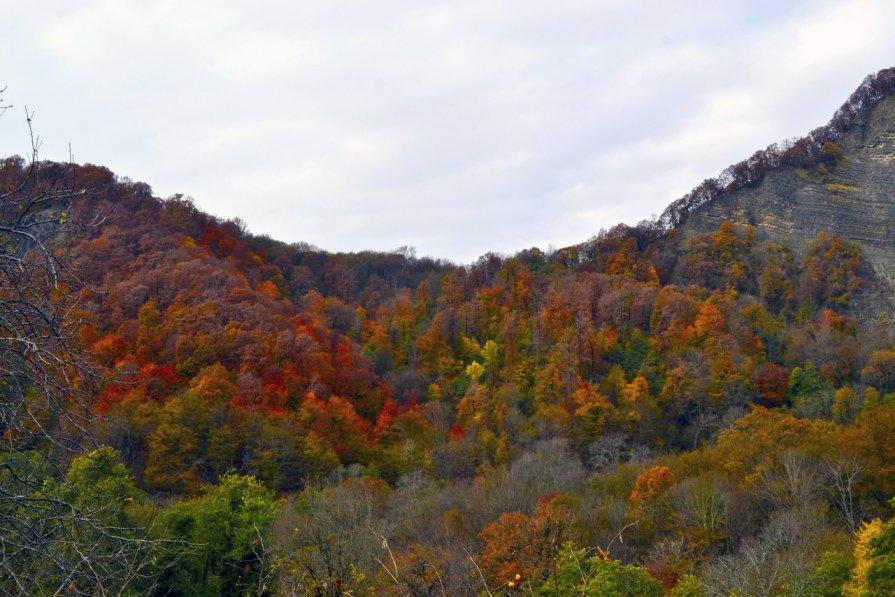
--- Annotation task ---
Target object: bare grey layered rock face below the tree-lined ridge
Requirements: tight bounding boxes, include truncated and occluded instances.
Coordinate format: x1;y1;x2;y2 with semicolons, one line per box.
678;95;895;310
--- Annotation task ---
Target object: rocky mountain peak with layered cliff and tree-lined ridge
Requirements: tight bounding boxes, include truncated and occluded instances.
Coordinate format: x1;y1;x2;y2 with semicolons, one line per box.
663;69;895;310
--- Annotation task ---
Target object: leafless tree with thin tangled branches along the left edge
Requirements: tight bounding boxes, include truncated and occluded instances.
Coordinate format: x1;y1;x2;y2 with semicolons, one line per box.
0;96;170;595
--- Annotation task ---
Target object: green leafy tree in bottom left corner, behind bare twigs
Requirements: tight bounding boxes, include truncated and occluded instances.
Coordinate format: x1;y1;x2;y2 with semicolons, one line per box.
0;448;166;595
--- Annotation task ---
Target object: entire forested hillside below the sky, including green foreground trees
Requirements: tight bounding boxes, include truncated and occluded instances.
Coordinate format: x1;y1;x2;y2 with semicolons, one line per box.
0;72;895;595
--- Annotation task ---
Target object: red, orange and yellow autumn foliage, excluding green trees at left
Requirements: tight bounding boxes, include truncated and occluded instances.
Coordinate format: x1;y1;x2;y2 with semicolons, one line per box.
4;155;895;594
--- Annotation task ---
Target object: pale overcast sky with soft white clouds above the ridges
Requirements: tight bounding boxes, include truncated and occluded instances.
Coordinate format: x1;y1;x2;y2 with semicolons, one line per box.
0;0;895;263
